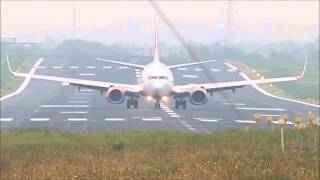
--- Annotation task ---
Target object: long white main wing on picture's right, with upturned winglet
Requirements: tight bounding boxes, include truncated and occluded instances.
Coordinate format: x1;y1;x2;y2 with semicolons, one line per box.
173;58;308;96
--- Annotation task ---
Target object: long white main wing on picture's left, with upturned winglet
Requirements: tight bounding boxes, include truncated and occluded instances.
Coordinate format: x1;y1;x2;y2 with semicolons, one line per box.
7;56;140;93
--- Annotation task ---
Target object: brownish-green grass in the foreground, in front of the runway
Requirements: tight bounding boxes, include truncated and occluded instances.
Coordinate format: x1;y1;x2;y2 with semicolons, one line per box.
1;128;319;180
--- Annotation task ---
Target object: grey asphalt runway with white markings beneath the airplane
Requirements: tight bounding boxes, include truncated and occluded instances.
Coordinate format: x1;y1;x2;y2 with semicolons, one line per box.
0;57;319;132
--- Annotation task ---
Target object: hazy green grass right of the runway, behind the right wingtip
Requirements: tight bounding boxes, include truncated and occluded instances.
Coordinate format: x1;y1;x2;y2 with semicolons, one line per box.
234;59;320;103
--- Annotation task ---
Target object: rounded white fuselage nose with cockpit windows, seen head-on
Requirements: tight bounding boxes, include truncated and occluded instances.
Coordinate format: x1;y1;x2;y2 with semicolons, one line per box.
141;61;173;98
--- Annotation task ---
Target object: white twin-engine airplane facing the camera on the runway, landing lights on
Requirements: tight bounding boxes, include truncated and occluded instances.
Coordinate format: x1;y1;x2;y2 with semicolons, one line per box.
6;11;308;109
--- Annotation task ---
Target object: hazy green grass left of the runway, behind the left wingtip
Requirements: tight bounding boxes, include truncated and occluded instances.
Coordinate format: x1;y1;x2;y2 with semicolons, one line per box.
0;56;37;96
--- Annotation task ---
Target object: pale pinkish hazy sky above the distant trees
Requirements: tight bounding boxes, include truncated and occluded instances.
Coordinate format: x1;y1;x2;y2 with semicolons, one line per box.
1;0;319;43
